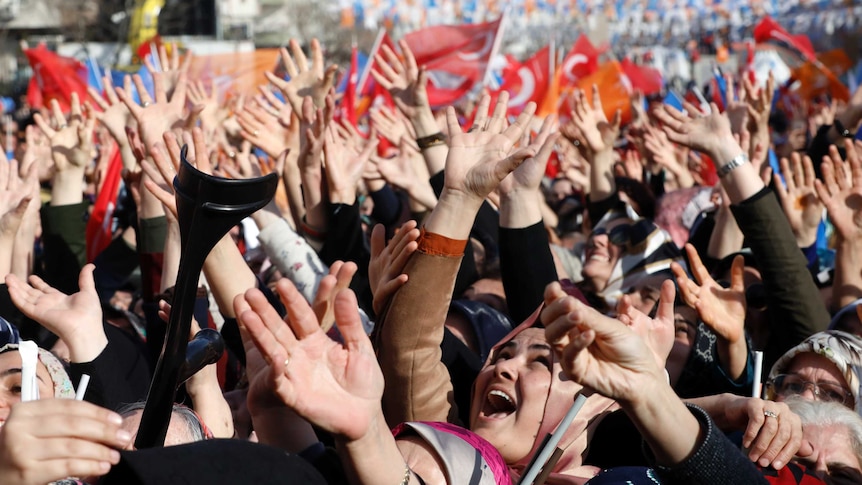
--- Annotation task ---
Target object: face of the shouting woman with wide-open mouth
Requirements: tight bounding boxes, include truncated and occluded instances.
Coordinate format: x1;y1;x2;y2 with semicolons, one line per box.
470;328;562;464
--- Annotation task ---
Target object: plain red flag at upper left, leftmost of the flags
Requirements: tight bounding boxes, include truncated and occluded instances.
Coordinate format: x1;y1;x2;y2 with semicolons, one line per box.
24;44;87;112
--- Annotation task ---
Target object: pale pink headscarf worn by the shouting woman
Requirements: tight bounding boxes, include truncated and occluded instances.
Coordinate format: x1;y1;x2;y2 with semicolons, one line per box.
485;306;619;485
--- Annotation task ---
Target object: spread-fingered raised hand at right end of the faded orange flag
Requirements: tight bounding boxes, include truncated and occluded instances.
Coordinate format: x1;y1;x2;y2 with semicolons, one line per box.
265;39;338;113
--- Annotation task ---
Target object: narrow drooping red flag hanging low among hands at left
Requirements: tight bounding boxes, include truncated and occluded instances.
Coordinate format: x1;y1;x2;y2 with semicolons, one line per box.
85;145;123;263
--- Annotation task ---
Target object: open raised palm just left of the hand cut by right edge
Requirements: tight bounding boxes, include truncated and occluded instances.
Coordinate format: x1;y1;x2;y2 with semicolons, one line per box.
772;152;823;248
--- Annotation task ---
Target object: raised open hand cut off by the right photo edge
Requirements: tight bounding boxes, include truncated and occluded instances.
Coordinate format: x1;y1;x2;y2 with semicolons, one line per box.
814;140;862;240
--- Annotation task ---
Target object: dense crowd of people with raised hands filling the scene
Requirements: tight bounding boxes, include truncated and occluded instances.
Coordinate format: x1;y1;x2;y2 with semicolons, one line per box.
0;27;862;485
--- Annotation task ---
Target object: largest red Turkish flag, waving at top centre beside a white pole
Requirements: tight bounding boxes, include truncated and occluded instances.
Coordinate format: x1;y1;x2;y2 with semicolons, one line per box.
404;17;502;106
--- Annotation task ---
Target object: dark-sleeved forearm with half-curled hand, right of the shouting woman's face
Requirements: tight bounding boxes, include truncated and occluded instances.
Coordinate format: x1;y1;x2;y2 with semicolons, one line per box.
541;283;766;483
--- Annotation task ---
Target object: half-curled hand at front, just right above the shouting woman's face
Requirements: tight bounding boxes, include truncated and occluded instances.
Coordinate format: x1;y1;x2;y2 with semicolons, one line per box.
540;283;665;402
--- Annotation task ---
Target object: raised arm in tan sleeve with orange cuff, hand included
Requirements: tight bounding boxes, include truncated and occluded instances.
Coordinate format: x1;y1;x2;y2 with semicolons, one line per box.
375;100;535;424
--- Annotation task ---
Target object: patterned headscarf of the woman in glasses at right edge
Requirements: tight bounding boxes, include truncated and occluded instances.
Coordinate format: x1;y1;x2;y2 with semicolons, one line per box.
768;330;862;415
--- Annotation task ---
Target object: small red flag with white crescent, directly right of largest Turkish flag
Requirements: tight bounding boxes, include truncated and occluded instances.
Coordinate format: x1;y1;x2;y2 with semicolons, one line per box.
500;46;551;115
